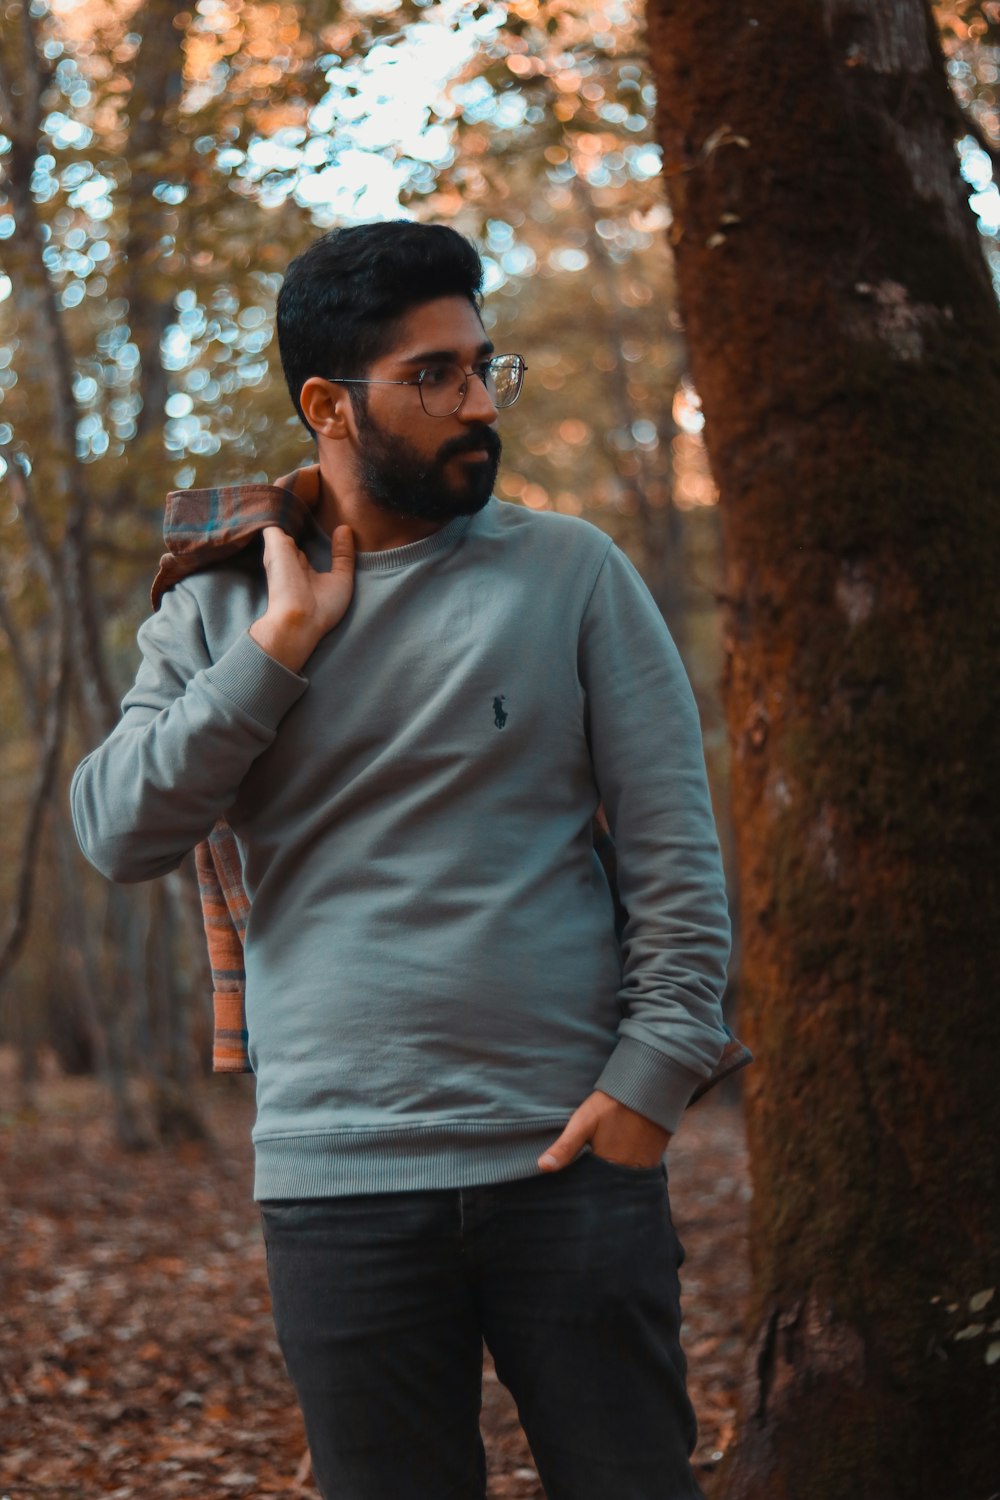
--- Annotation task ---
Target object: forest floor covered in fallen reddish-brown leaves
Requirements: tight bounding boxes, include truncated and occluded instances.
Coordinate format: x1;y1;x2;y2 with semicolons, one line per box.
0;1058;750;1500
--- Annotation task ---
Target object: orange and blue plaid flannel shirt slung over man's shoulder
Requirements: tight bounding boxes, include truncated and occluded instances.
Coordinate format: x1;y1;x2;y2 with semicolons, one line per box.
151;485;753;1104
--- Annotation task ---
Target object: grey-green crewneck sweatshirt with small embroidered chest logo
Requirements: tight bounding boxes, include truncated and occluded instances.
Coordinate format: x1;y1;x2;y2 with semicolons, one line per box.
70;500;729;1199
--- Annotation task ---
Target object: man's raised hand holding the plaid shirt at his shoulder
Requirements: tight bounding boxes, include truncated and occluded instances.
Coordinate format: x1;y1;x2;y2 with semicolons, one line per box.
250;525;354;672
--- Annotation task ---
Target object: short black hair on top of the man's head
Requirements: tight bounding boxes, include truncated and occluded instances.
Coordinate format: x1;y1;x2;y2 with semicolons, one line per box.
277;219;483;437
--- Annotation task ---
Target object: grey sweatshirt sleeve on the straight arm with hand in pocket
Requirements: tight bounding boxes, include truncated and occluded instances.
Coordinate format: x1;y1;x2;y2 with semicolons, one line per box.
579;546;730;1131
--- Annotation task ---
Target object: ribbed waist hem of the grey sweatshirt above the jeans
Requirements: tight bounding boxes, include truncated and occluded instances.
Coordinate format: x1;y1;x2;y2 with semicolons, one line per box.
253;1115;567;1202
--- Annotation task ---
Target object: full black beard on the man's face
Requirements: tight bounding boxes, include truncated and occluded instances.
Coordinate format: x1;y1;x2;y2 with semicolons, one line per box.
357;410;501;521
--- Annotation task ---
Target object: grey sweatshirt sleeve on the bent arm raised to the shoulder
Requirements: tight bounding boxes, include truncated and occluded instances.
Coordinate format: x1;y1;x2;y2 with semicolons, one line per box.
70;584;309;882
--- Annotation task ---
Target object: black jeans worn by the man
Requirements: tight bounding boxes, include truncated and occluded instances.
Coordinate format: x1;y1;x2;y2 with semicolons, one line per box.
261;1152;702;1500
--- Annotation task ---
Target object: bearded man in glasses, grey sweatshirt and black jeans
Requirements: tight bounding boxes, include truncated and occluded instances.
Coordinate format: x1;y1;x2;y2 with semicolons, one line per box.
72;222;729;1500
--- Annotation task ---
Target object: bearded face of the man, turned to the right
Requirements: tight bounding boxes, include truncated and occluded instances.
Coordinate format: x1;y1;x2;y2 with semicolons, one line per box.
355;297;501;521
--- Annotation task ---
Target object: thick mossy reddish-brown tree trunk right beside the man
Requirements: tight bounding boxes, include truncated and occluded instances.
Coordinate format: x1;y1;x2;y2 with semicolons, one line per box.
648;0;1000;1500
